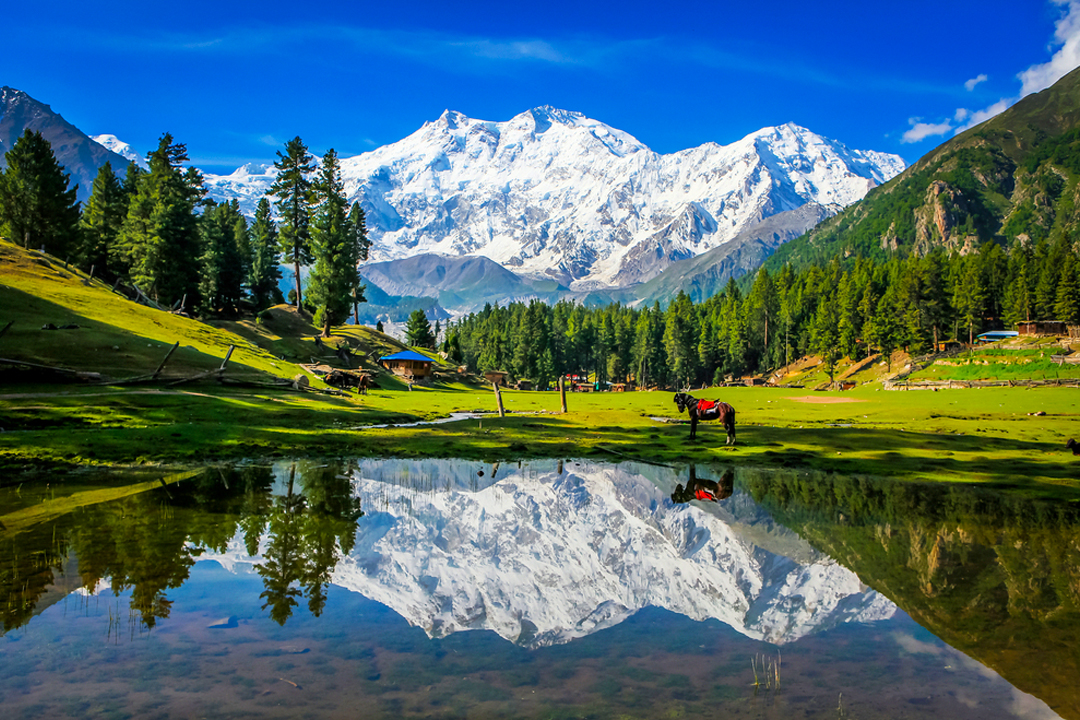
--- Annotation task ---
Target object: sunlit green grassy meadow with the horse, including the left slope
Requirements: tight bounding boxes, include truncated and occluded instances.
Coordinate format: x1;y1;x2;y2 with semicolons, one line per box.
0;237;1080;500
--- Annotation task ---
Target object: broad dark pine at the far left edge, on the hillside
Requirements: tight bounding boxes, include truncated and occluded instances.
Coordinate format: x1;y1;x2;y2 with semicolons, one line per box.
0;128;79;258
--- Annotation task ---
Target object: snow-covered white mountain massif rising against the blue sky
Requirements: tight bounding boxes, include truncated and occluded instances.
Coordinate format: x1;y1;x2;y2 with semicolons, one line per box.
200;107;904;289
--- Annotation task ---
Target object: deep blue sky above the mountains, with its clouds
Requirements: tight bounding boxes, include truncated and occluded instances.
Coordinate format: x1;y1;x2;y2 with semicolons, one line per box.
6;0;1080;172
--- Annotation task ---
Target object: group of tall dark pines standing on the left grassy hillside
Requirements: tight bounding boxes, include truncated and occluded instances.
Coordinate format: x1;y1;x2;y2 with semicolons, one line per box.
0;130;370;335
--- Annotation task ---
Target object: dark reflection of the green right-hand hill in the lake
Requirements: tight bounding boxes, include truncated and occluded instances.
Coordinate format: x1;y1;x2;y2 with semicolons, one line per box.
743;471;1080;718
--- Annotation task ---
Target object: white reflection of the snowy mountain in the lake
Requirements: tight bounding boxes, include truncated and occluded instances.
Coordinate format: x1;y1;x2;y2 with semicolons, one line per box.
203;461;895;647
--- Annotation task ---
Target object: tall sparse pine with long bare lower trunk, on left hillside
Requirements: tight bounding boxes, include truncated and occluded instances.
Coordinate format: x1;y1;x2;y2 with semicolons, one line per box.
267;136;315;310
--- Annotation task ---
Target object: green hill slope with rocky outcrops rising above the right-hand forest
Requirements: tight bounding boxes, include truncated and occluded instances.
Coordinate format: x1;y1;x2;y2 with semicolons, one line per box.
765;64;1080;272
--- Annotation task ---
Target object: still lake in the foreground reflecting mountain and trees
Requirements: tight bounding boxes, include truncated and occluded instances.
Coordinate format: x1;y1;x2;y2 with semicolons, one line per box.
0;460;1080;719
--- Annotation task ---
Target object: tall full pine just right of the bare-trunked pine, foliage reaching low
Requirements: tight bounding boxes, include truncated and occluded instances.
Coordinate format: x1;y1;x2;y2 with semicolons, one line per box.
308;149;357;337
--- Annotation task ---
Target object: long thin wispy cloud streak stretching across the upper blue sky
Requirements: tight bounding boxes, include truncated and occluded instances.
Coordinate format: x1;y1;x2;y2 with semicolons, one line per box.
39;24;949;94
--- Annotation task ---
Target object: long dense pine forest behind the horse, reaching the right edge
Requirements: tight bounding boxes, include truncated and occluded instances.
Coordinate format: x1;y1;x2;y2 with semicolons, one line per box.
441;235;1080;386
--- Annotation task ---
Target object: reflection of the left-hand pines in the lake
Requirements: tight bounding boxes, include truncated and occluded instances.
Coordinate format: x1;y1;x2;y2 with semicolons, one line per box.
0;463;363;633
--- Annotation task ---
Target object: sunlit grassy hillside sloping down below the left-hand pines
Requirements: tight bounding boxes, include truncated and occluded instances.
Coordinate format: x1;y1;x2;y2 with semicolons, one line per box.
0;240;438;382
